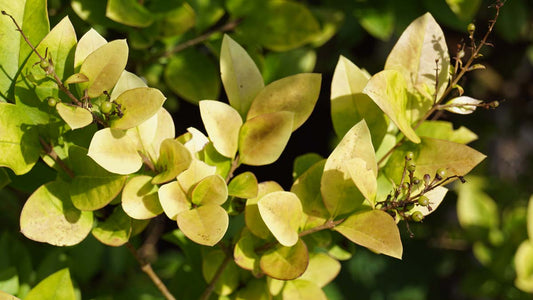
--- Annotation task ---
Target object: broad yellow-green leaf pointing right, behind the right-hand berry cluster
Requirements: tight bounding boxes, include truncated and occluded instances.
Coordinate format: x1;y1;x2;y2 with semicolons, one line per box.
384;138;486;182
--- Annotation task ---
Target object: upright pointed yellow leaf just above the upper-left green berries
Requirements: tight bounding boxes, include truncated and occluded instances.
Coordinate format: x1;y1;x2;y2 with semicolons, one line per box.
80;40;128;98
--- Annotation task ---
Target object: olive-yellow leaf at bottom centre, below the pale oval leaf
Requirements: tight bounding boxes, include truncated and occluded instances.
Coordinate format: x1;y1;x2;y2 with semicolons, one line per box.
259;239;309;280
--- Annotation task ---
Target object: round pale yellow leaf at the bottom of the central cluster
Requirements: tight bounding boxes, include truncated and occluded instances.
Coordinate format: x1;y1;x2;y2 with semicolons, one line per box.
177;204;229;246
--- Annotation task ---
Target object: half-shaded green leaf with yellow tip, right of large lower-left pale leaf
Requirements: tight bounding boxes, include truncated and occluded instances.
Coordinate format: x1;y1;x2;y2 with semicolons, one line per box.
92;206;132;247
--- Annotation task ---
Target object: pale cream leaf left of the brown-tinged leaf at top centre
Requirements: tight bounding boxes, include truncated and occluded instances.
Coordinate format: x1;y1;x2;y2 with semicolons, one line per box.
199;100;242;158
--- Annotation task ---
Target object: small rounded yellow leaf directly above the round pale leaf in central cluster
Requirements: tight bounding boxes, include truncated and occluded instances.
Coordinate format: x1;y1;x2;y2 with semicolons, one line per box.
191;175;228;205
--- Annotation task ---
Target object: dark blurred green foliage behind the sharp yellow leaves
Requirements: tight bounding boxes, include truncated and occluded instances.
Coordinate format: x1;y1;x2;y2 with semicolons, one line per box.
0;0;533;300
